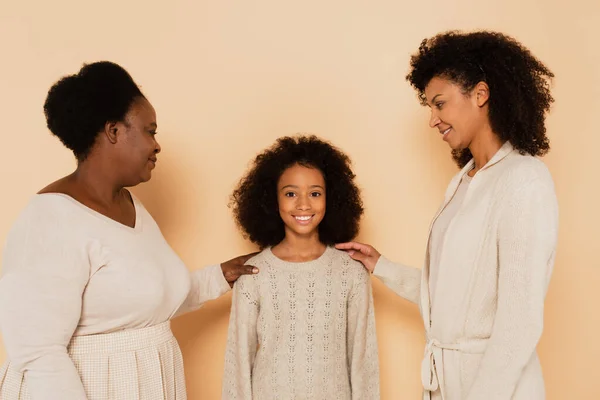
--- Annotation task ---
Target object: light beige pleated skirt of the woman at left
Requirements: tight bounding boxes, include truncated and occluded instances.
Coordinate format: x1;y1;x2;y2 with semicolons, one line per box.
0;322;186;400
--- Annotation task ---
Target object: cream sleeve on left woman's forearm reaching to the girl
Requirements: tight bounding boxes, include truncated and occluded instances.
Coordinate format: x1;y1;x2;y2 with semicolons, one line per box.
175;264;231;316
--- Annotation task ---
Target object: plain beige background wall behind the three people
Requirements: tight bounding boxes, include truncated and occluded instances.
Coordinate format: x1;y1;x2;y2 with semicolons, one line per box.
0;0;600;400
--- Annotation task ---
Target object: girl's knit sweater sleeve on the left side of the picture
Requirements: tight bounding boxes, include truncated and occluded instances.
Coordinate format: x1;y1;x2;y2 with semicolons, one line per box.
222;275;260;400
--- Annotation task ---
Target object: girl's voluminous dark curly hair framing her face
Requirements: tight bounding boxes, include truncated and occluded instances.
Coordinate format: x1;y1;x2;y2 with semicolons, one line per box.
229;136;363;248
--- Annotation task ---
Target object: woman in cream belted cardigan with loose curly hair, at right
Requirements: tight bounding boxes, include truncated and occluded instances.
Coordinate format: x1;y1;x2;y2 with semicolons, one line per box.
339;32;558;400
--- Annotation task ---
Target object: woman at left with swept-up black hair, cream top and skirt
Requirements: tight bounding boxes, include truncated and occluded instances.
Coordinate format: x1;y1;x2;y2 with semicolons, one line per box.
0;62;257;400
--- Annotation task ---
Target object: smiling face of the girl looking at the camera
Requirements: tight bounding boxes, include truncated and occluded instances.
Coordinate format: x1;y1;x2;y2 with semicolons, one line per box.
277;164;326;238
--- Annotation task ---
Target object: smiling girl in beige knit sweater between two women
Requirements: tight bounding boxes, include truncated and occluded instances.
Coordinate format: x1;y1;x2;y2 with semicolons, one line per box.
222;136;379;400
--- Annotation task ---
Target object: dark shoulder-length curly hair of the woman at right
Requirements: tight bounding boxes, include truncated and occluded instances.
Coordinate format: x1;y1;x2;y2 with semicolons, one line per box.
406;31;554;167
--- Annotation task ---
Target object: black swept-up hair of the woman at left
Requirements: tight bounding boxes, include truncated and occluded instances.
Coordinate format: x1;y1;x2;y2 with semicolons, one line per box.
44;61;144;161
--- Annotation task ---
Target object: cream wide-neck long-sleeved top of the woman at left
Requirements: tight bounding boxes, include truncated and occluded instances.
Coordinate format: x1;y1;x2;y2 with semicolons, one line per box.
0;193;230;400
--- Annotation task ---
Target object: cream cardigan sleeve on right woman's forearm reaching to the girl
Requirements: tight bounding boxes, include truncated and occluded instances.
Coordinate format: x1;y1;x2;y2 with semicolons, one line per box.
373;256;421;304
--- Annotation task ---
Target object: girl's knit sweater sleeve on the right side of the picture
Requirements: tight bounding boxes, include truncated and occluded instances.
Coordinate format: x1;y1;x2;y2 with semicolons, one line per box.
347;266;379;400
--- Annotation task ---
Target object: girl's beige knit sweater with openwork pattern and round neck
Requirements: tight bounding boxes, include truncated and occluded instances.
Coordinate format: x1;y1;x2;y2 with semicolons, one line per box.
222;247;379;400
